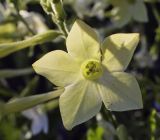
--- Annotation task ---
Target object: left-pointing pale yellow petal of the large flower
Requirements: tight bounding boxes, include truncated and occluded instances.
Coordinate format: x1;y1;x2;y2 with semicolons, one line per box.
33;50;80;86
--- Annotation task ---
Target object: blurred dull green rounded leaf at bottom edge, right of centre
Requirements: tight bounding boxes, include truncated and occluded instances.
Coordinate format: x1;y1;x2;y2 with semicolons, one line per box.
116;124;129;140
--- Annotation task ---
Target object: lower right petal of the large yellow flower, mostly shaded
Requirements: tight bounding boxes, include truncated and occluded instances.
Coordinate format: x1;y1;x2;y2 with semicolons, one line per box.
98;72;143;111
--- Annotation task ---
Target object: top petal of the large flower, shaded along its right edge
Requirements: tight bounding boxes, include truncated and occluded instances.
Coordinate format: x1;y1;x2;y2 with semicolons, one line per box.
66;20;100;60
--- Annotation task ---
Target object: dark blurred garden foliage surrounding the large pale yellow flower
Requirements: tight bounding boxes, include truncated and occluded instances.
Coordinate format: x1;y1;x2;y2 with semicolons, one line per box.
0;0;160;140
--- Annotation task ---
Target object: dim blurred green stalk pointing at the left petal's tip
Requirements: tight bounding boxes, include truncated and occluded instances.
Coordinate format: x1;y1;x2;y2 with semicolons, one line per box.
0;68;33;78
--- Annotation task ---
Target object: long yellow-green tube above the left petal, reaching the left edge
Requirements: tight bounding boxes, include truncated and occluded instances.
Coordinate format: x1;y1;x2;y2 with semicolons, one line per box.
0;30;60;58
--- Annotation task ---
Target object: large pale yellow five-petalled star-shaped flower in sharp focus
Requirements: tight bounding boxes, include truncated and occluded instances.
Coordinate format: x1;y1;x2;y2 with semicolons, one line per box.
33;20;143;130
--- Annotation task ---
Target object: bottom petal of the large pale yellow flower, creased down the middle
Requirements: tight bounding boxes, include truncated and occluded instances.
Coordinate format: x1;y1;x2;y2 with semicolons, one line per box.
60;80;102;130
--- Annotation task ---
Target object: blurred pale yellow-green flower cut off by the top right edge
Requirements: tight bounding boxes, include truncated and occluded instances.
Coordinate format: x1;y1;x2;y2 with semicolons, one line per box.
109;0;148;27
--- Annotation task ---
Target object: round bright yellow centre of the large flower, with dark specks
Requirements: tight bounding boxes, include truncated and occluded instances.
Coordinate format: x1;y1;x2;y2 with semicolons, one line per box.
81;60;103;80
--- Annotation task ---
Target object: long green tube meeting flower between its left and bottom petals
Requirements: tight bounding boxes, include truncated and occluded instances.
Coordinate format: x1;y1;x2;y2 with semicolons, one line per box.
2;89;64;115
